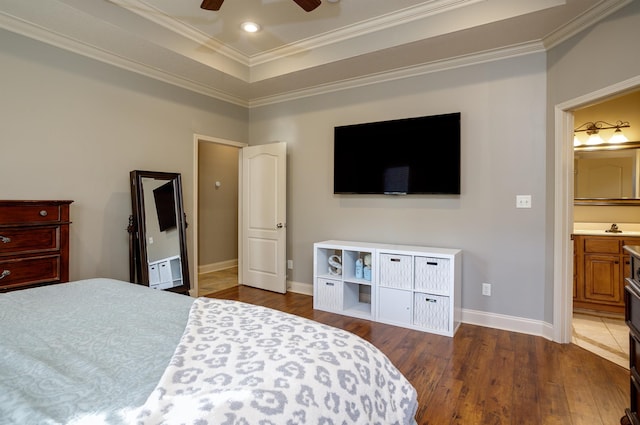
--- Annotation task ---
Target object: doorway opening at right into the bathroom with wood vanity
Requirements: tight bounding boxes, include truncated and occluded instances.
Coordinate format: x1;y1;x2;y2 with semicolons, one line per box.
572;90;640;368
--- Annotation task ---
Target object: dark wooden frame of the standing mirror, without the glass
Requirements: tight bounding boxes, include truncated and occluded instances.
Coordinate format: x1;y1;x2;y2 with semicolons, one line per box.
129;170;191;295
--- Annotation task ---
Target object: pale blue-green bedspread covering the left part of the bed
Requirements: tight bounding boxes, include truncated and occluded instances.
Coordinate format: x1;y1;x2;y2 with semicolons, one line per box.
0;279;193;424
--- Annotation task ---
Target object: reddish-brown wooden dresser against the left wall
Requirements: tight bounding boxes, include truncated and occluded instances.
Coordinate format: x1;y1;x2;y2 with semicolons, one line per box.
0;201;73;292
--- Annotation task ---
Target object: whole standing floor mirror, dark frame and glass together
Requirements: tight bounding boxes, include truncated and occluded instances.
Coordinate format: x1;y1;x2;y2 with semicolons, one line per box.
131;170;190;293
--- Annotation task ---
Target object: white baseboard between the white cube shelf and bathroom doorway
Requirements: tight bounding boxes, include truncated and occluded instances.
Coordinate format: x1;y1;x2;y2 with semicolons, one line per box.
462;309;553;340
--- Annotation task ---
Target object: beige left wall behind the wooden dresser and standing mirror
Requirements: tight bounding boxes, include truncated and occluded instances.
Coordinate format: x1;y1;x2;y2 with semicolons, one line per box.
0;30;248;280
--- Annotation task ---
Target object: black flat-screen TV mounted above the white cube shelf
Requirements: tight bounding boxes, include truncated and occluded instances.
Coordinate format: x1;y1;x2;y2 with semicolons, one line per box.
333;112;460;195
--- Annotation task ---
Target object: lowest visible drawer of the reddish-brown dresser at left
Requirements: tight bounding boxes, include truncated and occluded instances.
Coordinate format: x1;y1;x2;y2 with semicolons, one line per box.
0;255;61;291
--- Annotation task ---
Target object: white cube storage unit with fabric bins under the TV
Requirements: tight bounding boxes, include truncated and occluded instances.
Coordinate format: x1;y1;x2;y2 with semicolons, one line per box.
313;240;462;336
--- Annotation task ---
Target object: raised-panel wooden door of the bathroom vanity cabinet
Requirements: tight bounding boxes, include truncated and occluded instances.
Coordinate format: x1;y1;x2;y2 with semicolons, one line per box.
584;254;622;304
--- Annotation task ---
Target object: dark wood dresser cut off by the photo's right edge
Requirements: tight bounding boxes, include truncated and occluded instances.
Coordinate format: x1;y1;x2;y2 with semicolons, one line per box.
620;245;640;425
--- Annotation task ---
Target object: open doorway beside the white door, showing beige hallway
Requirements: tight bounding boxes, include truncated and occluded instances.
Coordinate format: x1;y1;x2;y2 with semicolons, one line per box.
193;135;247;296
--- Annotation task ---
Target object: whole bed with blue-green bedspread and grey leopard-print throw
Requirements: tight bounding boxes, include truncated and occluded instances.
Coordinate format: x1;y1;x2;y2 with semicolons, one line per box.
0;279;417;425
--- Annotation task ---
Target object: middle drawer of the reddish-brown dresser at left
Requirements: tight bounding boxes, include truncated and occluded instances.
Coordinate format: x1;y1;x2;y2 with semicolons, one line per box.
0;226;60;257
